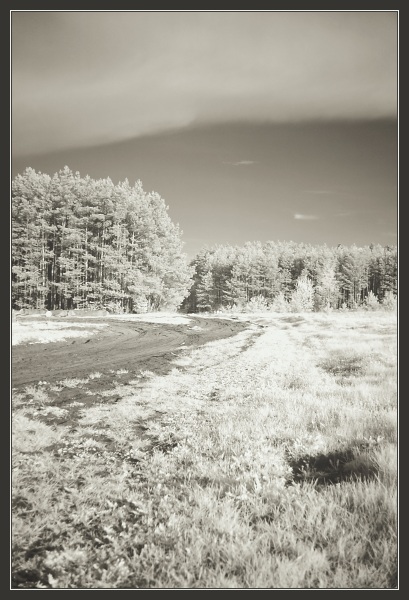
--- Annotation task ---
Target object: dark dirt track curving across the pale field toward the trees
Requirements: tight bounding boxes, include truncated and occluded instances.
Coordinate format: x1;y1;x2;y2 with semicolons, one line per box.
12;316;246;389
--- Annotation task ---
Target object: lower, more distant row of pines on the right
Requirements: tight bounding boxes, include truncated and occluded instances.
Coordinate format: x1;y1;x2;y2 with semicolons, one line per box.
183;241;398;312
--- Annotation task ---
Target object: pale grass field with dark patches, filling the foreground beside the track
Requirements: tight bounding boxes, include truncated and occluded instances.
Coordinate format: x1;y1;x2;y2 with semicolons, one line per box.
12;311;398;589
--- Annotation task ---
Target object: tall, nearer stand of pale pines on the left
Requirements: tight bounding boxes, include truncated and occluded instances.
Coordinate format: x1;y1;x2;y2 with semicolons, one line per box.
11;167;193;312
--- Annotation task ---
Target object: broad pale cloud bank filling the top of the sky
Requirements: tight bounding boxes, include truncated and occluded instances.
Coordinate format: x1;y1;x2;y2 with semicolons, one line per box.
12;11;397;157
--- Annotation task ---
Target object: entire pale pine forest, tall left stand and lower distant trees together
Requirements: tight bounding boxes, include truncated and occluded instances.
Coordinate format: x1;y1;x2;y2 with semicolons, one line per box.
11;167;398;312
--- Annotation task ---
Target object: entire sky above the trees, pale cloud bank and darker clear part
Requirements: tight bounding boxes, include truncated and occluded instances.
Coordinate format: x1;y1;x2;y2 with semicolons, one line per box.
11;11;398;257
